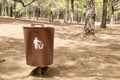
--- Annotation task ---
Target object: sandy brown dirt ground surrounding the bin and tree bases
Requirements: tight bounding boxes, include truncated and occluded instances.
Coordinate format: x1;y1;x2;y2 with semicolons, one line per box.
0;18;120;80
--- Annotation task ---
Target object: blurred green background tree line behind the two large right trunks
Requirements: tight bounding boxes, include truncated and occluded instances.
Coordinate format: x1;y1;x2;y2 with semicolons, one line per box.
0;0;120;23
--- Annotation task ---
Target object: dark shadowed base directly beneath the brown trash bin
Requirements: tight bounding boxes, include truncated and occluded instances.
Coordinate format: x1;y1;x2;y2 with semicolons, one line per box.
30;66;48;77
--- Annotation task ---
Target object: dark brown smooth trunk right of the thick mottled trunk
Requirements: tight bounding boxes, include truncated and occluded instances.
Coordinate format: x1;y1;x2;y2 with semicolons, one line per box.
100;0;108;28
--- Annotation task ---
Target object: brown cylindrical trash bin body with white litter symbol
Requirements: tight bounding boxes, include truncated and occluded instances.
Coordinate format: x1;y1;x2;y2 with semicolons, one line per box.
24;27;54;67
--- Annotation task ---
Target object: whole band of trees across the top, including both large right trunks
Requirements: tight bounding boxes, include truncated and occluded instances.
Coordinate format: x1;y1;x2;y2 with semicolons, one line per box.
0;0;120;33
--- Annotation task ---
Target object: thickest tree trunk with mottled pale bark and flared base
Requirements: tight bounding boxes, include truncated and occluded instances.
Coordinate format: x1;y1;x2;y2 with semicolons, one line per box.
84;0;95;35
